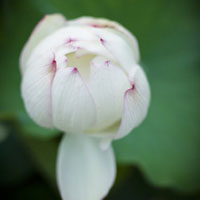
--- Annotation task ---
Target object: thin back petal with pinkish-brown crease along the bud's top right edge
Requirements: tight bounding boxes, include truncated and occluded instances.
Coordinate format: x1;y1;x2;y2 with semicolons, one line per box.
69;17;139;62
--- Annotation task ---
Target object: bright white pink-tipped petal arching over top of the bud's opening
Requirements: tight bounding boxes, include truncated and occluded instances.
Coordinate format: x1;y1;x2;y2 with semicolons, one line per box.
26;26;112;74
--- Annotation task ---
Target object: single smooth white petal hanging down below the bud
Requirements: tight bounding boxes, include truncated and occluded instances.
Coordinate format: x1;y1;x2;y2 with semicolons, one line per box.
57;135;116;200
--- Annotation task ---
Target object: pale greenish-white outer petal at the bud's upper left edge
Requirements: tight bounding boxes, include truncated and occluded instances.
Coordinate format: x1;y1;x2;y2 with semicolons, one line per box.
20;14;66;72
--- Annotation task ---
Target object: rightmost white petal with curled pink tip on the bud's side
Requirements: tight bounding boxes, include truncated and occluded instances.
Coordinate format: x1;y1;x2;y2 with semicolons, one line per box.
116;66;150;139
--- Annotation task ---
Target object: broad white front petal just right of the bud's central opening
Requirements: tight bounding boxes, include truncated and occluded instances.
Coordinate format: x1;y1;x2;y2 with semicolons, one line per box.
88;57;130;129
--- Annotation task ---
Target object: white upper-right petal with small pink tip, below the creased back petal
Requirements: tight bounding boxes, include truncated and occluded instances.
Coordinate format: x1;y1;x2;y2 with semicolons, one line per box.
92;28;139;72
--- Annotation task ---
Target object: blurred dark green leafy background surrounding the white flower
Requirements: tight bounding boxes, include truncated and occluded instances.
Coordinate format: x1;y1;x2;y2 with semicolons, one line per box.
0;0;200;200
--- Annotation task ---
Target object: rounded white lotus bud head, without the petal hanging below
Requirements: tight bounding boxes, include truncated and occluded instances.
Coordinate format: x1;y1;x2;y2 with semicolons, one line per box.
21;14;150;138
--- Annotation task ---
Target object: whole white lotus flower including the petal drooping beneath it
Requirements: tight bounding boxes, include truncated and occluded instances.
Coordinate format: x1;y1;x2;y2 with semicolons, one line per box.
20;14;150;200
